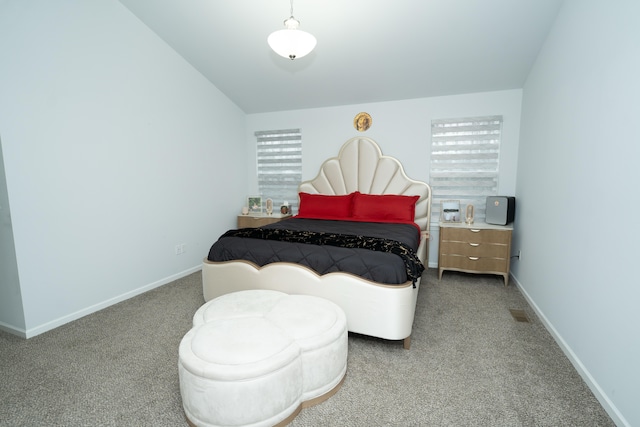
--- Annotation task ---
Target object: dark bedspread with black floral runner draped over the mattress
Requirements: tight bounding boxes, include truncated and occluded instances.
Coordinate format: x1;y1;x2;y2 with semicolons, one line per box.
208;218;424;285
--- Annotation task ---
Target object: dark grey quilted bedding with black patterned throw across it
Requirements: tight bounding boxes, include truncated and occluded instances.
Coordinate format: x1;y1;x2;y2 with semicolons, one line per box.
208;218;424;285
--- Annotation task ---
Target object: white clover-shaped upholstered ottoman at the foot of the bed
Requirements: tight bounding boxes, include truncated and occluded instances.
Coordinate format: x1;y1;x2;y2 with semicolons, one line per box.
178;290;347;427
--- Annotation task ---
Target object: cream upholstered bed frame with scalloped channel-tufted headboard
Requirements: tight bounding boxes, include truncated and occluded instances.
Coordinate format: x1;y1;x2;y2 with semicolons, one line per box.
202;137;431;349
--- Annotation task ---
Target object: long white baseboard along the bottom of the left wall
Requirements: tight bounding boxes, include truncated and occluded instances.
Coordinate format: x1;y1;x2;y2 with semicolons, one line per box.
21;264;202;339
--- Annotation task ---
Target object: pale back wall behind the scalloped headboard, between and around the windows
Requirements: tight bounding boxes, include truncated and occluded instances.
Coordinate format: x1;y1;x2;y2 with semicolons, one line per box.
246;90;522;267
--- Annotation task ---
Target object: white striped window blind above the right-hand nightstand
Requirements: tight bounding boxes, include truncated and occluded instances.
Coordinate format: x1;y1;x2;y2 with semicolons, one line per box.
429;116;502;224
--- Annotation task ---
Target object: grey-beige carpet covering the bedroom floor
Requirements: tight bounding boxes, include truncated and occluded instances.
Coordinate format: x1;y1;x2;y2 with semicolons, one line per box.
0;269;613;427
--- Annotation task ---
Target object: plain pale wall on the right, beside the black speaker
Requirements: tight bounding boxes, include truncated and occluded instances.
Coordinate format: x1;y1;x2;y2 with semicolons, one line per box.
513;0;640;425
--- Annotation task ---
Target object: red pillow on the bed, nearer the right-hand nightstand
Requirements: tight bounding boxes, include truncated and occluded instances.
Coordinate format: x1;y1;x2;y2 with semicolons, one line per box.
352;193;420;222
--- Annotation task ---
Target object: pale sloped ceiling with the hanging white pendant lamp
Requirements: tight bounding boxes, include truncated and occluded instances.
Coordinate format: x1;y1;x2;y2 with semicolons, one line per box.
120;0;563;114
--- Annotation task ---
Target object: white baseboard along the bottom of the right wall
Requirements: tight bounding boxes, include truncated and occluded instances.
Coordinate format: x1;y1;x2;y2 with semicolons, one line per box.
511;274;631;427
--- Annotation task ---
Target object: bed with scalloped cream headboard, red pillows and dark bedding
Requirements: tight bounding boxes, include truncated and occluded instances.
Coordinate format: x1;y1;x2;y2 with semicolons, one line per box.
202;137;431;349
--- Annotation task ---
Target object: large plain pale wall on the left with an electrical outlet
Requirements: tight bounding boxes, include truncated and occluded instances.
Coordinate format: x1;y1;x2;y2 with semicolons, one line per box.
0;0;247;336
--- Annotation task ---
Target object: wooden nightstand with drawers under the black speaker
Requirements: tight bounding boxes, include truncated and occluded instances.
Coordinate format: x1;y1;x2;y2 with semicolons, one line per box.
438;222;513;286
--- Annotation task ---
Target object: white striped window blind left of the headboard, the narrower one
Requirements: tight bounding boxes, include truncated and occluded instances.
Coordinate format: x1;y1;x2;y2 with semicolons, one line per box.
255;129;302;212
